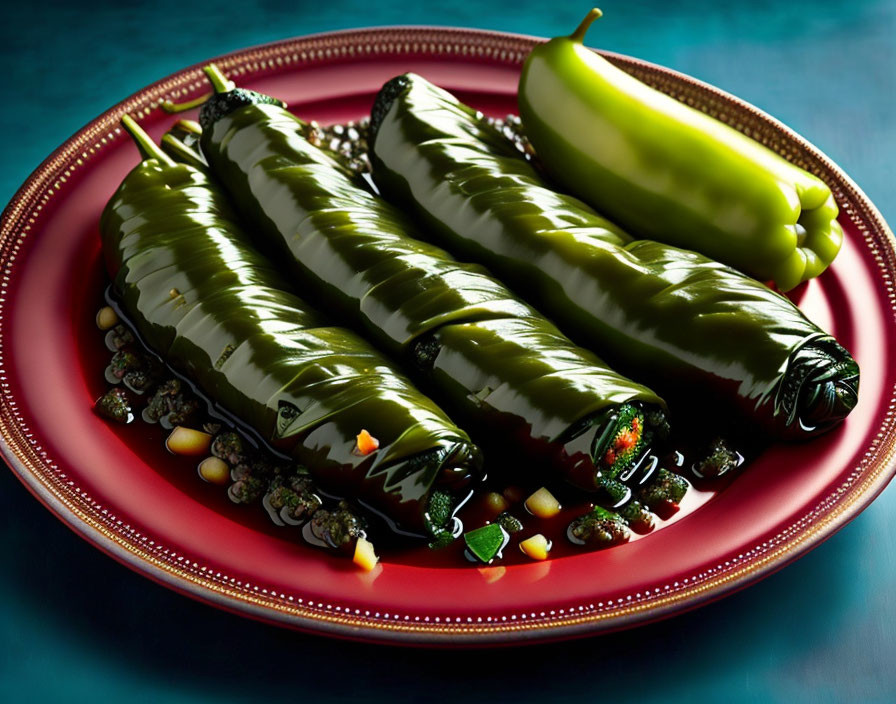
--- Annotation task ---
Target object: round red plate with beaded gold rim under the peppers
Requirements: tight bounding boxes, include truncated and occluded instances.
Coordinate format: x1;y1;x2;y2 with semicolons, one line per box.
0;28;896;644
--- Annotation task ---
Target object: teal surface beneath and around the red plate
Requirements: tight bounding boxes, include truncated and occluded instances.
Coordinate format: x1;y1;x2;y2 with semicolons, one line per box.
0;0;896;702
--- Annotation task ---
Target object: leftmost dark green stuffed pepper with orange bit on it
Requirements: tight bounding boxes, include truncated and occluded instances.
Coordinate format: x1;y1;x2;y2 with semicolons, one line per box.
100;118;481;535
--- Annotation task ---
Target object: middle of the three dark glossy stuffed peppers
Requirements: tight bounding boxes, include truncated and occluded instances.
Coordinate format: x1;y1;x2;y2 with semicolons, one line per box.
201;93;664;491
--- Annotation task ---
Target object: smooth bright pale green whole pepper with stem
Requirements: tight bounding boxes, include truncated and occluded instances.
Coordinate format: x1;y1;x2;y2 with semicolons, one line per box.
518;11;843;291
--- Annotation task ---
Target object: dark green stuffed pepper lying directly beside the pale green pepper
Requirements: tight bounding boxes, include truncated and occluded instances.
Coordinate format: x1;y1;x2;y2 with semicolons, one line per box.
371;74;858;438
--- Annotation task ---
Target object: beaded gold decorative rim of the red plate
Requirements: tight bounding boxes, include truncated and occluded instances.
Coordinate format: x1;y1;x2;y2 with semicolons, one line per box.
0;27;896;645
